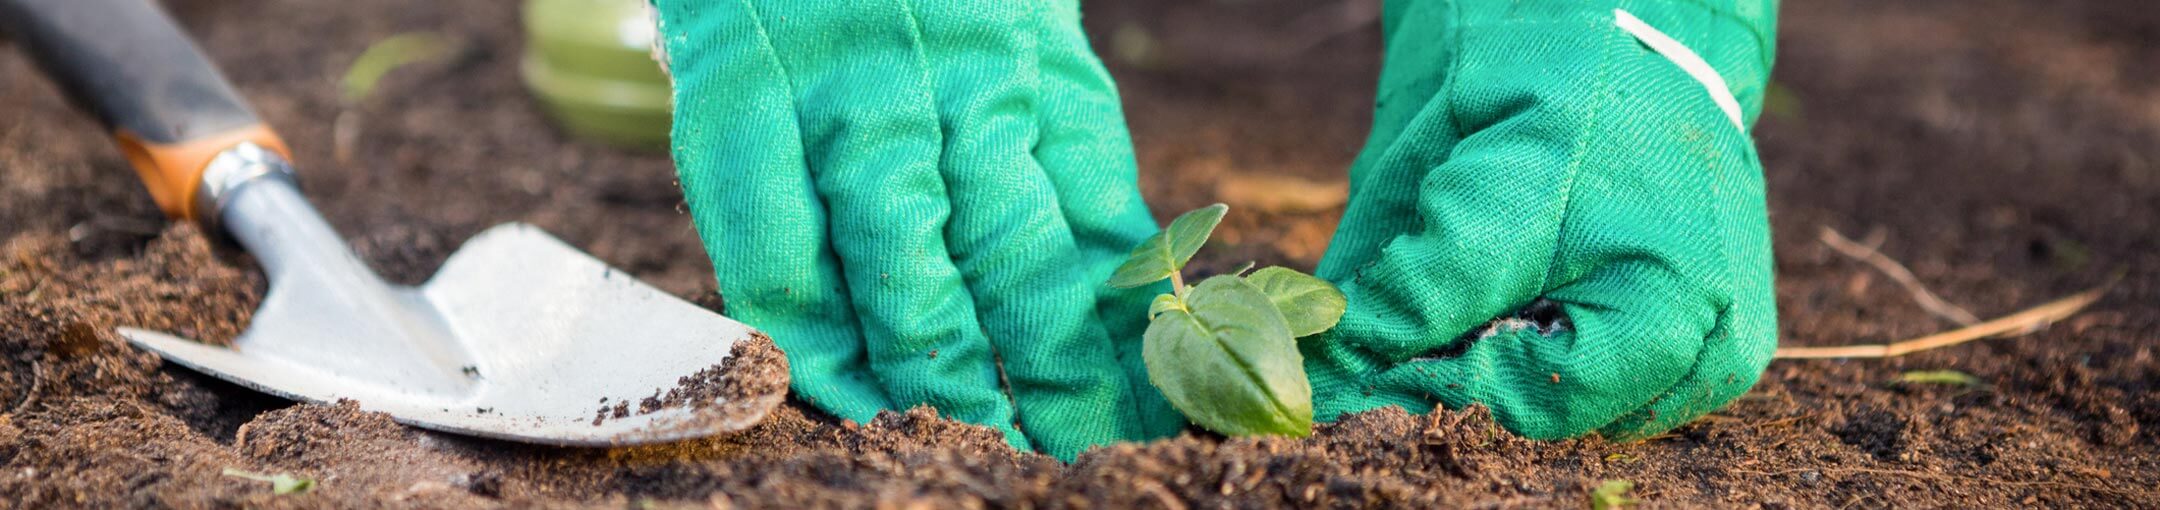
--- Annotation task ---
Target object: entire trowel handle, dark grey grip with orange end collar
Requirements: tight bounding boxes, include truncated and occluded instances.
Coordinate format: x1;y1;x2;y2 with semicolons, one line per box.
0;0;292;220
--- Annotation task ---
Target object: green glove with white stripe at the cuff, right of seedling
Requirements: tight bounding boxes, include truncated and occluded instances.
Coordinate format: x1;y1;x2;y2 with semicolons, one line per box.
1302;0;1778;441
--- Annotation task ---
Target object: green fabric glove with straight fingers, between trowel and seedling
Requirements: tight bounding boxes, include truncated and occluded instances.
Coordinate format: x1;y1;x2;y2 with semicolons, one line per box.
657;0;1184;458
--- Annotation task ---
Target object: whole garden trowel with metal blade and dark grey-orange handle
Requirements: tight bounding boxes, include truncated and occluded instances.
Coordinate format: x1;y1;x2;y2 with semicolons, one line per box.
0;0;786;445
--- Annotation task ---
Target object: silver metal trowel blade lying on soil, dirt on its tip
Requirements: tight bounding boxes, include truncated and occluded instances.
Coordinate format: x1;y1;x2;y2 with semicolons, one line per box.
121;223;782;445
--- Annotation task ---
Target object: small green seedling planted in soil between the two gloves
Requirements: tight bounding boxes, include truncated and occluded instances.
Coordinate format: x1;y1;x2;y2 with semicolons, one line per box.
1110;203;1348;437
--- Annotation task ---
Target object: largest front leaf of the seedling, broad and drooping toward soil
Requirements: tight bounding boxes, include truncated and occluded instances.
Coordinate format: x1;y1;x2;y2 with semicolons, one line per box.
1140;274;1313;437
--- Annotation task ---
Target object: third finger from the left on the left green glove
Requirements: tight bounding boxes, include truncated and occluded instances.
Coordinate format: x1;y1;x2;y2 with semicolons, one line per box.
920;0;1138;460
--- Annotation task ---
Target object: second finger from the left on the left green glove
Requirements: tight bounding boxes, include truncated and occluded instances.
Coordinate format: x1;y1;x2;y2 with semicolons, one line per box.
756;0;1026;447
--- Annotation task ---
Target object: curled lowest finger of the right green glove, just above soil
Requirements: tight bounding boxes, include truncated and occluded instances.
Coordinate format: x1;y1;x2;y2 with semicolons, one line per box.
1372;259;1728;439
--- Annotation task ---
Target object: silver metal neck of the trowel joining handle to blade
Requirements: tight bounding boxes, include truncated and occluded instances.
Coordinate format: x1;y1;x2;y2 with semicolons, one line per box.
194;143;469;385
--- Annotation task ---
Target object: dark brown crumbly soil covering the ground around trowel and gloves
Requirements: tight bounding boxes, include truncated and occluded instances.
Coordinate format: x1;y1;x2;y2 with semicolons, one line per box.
0;0;2160;508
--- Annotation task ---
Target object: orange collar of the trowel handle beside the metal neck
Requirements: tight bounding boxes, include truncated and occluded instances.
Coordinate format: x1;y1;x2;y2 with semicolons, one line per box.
112;123;292;220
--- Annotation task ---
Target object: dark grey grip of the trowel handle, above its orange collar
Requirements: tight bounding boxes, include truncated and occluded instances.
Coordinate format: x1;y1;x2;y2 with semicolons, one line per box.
0;0;259;145
